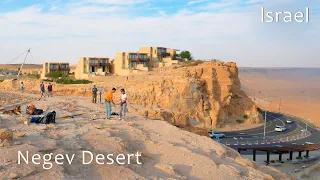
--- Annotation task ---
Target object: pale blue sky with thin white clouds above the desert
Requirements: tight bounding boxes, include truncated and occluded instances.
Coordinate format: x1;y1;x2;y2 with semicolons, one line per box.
0;0;320;67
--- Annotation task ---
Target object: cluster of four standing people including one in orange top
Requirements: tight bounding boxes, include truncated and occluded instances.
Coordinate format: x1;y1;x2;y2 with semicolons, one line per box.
92;85;127;121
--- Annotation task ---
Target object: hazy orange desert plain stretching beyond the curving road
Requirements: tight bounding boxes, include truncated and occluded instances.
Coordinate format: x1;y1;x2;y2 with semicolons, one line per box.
239;68;320;126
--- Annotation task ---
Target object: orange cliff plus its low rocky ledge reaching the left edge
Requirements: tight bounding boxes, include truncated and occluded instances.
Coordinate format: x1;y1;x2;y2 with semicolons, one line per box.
0;62;262;127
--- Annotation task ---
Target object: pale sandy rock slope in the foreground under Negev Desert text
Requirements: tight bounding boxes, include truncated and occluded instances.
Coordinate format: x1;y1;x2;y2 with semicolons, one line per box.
0;92;288;180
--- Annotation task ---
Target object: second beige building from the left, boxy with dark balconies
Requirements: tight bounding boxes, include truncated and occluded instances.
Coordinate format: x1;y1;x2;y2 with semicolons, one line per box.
74;57;112;79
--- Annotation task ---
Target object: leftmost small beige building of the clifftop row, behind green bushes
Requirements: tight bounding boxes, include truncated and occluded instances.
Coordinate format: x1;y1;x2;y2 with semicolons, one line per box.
41;62;70;78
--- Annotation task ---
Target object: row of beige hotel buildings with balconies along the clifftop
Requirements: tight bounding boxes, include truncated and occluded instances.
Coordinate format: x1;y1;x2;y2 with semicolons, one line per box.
42;47;179;79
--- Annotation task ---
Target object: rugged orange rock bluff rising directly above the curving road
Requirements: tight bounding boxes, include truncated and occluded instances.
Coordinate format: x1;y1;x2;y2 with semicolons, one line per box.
129;62;262;127
